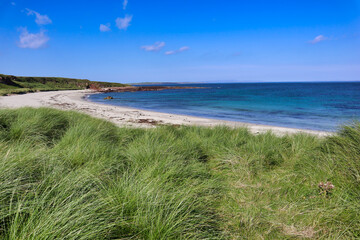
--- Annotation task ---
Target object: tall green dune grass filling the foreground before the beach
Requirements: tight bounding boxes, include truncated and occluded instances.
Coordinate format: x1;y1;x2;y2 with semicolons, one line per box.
0;108;360;240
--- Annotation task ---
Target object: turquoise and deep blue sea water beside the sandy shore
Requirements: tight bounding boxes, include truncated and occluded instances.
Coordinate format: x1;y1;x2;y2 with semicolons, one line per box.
88;82;360;131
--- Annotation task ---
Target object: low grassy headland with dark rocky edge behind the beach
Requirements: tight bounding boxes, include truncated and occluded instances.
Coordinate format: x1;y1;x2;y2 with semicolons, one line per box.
0;74;127;96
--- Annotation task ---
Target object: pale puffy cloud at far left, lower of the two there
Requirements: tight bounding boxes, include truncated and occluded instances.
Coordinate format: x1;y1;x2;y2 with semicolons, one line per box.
18;28;50;49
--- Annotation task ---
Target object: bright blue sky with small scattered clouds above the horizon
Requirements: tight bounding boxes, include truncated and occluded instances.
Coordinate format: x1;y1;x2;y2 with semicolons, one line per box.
0;0;360;83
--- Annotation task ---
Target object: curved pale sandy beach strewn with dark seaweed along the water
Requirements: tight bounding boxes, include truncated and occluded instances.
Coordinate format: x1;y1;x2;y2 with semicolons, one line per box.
0;90;332;136
